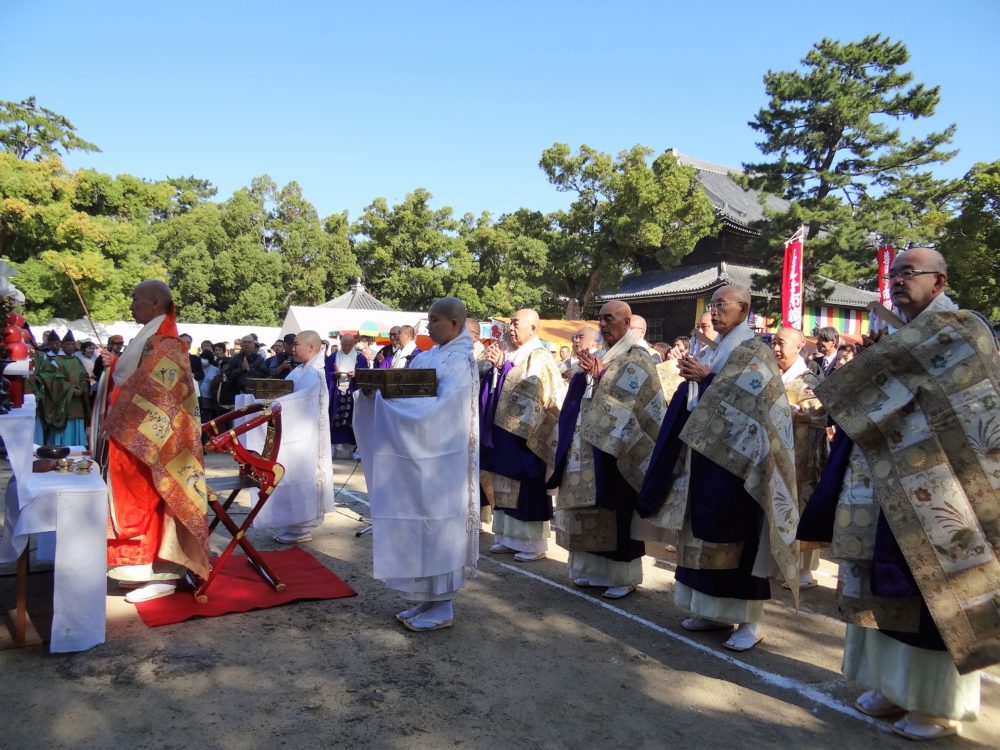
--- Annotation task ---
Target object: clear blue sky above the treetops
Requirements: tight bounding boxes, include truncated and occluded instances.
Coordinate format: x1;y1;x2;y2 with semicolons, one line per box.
0;0;1000;218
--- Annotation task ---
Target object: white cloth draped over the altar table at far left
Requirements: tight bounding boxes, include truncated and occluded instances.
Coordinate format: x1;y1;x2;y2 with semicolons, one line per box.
0;398;108;652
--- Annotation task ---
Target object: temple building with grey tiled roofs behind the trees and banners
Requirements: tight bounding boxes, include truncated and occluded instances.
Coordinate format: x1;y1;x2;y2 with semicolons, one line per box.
598;150;878;342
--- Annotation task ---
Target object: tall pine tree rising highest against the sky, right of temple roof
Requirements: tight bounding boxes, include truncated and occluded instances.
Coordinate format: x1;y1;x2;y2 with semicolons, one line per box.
744;35;955;290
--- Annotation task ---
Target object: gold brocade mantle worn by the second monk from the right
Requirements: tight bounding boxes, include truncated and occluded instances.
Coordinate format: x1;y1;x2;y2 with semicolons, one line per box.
660;339;799;598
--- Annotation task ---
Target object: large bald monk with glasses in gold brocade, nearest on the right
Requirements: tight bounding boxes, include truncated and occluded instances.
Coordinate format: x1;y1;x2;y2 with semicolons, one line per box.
799;247;1000;740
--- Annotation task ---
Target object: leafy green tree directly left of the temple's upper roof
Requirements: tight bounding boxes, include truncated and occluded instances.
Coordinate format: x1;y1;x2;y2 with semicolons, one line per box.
539;143;716;309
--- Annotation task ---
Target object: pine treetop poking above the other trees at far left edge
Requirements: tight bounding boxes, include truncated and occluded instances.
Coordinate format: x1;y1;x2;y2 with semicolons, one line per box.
0;96;100;159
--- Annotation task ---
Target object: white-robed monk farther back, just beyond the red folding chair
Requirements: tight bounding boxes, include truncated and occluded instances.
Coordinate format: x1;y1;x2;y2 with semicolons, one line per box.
253;331;334;544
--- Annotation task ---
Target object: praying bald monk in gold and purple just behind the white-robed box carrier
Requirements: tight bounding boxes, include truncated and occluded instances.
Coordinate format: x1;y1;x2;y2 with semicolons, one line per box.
480;309;565;562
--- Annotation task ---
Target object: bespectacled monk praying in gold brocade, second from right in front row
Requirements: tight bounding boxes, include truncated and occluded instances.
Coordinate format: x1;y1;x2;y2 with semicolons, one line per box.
637;285;799;651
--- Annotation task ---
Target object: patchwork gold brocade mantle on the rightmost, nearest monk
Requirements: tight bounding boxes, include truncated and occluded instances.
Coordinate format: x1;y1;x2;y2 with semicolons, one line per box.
817;311;1000;674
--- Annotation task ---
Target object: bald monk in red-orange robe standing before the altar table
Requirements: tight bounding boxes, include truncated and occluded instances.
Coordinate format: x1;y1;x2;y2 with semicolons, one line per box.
102;280;209;602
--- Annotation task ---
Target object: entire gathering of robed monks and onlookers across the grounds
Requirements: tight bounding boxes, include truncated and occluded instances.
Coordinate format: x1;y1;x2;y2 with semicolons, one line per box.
25;248;1000;740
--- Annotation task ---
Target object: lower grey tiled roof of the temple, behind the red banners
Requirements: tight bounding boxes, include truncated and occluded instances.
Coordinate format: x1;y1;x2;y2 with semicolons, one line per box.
601;262;878;307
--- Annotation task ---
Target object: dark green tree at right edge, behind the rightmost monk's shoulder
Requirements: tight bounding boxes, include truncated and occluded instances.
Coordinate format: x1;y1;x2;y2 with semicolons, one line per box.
941;160;1000;323
